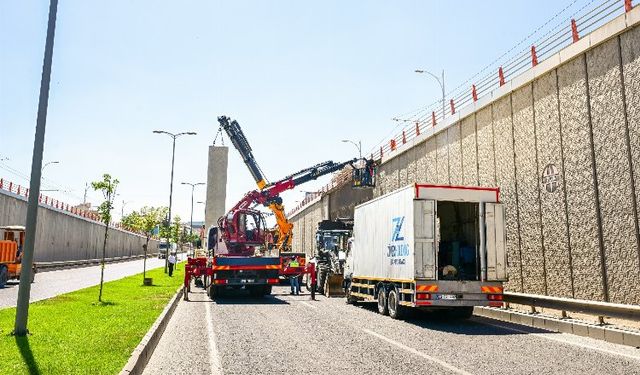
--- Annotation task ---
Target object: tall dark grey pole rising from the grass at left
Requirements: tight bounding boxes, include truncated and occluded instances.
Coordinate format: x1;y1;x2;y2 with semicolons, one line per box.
13;0;58;336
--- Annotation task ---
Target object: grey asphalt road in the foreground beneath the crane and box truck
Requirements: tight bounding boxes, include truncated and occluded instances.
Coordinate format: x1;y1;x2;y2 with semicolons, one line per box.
145;287;640;375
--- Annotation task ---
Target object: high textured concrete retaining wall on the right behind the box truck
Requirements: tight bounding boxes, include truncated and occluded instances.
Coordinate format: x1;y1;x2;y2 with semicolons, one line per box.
293;8;640;304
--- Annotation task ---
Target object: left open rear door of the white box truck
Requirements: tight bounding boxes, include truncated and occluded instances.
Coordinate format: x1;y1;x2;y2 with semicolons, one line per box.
413;200;437;280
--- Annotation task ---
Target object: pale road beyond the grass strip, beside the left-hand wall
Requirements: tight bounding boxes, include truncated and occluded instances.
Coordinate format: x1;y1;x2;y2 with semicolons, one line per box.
0;258;164;309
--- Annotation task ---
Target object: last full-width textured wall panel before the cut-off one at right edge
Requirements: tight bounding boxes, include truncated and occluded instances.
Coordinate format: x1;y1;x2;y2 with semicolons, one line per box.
587;38;640;303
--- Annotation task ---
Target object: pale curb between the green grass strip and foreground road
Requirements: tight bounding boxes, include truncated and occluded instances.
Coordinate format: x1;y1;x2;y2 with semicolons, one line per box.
120;286;184;375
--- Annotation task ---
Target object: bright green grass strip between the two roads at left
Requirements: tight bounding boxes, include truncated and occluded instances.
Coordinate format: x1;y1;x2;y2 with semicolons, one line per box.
0;264;184;374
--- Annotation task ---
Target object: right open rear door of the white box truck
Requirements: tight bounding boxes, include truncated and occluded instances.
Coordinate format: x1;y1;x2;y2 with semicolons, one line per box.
484;203;507;281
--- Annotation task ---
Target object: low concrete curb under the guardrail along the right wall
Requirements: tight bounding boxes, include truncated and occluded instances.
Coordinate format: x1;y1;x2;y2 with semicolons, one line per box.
473;307;640;348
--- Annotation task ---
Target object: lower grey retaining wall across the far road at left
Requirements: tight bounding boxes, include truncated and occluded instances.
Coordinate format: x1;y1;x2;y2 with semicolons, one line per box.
0;190;158;262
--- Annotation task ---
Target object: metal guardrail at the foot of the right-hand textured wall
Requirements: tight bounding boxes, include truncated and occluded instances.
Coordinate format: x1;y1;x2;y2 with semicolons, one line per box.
504;292;640;321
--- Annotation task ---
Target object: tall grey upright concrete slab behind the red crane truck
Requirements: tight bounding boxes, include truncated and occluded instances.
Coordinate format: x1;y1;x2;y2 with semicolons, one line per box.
204;146;229;230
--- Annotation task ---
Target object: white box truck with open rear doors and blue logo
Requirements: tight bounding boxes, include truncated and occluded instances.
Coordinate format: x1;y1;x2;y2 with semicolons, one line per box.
344;184;507;319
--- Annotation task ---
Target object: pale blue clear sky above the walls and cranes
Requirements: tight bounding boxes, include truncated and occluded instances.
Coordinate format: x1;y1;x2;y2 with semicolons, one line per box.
0;0;590;220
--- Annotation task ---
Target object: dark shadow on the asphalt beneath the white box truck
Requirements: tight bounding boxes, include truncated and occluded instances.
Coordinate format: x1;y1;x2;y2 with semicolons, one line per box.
350;303;553;336
